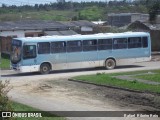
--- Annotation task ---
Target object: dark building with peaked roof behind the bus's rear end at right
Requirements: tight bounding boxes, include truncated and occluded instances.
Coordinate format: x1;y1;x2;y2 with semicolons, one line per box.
128;21;160;51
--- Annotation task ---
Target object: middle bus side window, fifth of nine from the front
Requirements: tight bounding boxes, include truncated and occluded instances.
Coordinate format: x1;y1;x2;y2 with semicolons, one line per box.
83;40;97;51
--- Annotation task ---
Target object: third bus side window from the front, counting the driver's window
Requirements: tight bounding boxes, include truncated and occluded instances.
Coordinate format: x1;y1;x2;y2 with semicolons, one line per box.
51;41;66;53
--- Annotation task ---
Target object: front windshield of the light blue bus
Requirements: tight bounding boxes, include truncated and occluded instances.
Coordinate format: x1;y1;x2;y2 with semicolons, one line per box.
11;40;22;64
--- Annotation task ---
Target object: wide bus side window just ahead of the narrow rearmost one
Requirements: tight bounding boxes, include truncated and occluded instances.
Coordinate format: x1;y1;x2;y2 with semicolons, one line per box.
128;37;142;49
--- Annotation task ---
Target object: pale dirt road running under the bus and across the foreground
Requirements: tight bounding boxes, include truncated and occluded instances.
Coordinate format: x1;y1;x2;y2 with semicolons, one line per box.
1;62;160;120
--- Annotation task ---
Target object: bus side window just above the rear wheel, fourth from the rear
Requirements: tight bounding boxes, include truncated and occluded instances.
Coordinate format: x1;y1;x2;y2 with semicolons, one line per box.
98;39;112;50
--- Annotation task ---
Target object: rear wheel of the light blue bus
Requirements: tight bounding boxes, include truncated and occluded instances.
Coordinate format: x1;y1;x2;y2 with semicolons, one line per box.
105;59;116;70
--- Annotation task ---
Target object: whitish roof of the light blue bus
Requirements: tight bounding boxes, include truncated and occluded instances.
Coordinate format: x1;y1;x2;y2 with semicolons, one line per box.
14;32;149;42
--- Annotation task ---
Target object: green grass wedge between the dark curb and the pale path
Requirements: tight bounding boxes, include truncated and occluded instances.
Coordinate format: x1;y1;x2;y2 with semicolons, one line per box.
73;71;160;93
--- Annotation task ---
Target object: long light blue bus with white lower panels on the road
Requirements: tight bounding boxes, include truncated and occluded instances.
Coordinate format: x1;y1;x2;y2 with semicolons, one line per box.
10;32;151;74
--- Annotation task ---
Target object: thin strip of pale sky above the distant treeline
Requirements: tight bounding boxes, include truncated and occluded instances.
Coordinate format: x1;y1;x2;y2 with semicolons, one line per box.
0;0;124;5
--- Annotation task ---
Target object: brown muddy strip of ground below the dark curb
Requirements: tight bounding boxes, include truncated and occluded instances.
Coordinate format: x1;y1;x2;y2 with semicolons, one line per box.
34;79;160;111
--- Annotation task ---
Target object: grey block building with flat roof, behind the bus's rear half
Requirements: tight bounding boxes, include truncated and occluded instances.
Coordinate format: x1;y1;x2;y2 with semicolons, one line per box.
108;13;149;27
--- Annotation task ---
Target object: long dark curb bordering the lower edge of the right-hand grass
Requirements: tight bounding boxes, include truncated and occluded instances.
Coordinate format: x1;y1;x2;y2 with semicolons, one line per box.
68;78;160;95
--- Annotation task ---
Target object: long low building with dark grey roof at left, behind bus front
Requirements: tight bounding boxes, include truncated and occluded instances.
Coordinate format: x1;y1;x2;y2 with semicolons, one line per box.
0;20;77;54
